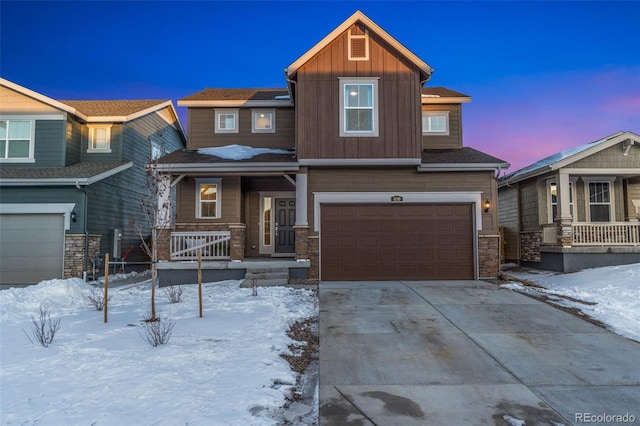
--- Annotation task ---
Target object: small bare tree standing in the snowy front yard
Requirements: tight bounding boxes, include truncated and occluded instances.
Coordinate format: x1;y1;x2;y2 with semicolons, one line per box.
134;130;173;321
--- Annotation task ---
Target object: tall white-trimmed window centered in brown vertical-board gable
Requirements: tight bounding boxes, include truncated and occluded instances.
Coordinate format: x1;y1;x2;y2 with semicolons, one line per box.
340;78;378;137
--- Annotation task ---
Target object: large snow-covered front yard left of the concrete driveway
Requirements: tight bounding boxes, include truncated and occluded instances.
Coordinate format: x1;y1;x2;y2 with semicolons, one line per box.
0;279;318;426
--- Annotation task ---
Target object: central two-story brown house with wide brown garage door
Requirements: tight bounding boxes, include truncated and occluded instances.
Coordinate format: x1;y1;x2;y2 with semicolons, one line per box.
152;11;508;284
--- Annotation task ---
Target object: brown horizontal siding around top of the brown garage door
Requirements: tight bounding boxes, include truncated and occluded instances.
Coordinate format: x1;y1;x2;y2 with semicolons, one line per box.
307;168;498;233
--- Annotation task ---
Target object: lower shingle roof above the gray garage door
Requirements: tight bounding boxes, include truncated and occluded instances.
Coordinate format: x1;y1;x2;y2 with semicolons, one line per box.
0;161;128;180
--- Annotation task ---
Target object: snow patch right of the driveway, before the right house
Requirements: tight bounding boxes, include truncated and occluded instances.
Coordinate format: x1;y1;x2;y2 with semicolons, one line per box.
503;263;640;342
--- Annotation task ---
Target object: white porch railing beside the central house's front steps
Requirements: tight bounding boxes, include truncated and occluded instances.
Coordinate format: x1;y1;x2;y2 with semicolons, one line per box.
171;231;231;260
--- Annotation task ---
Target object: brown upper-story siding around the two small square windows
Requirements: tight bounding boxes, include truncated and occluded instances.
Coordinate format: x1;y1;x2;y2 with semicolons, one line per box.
187;107;295;149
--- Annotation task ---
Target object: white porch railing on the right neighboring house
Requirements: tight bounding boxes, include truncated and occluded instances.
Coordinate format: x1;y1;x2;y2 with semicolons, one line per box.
571;222;640;246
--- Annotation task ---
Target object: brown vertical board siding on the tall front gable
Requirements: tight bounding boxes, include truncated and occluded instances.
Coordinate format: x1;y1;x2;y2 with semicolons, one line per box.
296;25;422;159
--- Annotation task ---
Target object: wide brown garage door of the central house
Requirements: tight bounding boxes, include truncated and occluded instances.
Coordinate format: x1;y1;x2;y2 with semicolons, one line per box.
320;204;474;281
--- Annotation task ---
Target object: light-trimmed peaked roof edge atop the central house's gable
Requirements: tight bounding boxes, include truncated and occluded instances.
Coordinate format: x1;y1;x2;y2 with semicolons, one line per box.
285;10;434;81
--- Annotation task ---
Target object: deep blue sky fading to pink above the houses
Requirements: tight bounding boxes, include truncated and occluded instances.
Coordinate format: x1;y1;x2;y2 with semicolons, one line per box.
0;0;640;171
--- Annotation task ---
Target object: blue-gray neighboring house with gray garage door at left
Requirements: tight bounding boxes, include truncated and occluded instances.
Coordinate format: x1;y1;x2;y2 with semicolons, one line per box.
0;79;186;284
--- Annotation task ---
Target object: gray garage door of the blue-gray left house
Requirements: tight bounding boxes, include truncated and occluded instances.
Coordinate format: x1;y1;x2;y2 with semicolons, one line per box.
0;214;64;284
